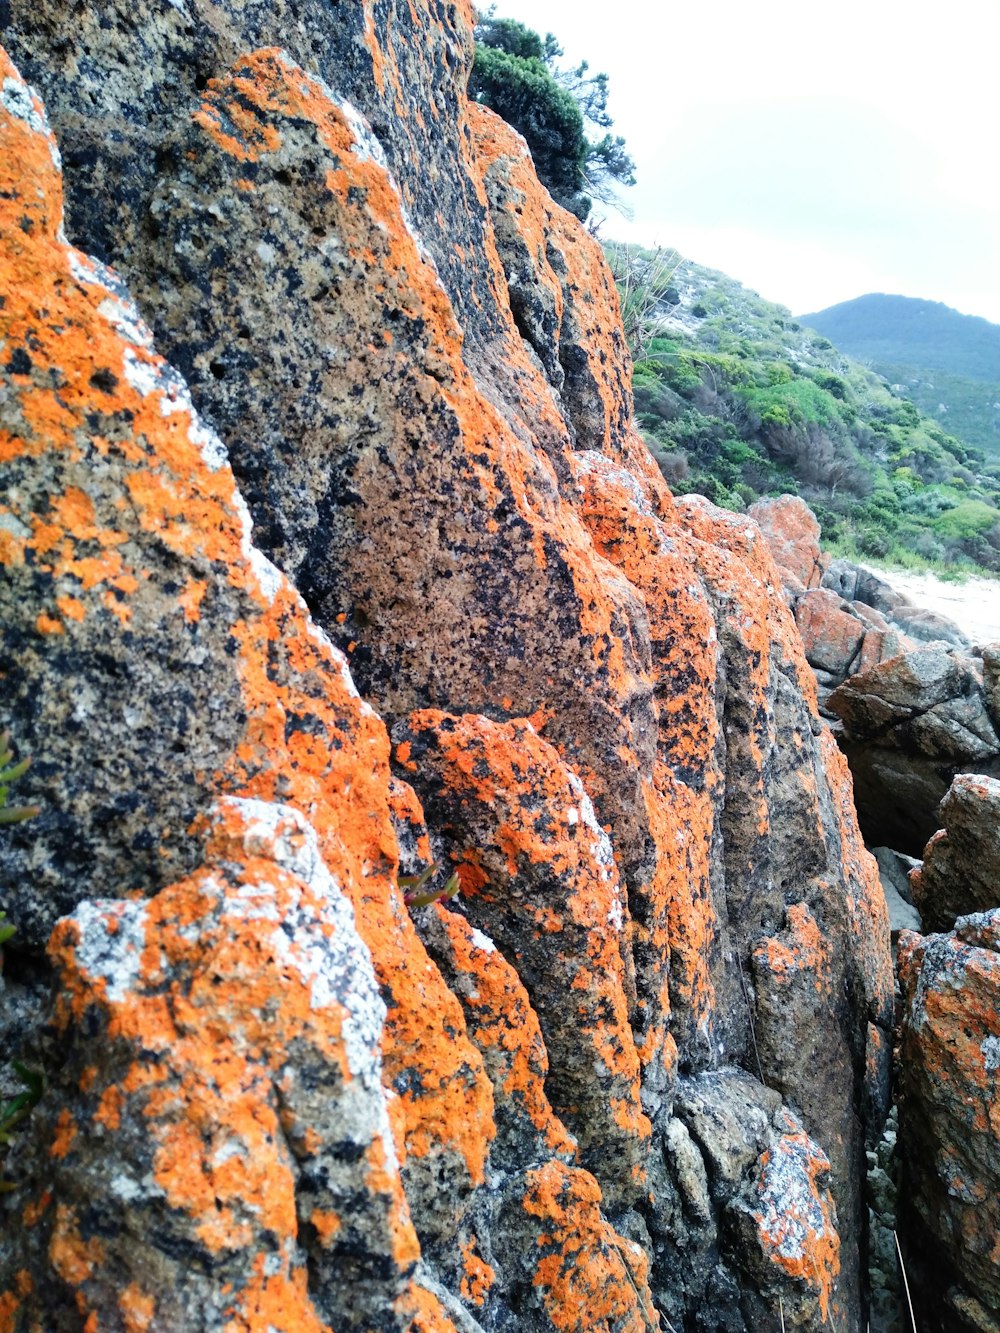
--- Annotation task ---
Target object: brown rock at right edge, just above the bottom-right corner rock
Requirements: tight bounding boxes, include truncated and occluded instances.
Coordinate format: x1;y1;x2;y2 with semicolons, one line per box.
909;773;1000;930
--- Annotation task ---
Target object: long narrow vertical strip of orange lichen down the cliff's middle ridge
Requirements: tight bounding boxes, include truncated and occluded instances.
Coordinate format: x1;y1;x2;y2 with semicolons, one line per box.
571;455;723;1065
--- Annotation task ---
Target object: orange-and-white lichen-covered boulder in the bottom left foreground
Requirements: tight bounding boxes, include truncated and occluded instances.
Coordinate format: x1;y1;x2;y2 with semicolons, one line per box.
3;798;444;1333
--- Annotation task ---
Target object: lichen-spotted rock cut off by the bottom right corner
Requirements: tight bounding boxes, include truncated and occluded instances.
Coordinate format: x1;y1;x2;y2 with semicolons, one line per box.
899;910;1000;1333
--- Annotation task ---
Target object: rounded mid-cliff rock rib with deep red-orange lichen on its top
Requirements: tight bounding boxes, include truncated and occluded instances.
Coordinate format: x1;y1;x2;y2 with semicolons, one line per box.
400;709;651;1194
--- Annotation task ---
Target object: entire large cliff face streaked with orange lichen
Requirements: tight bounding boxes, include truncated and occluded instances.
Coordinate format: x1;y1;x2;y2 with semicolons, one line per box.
0;0;891;1333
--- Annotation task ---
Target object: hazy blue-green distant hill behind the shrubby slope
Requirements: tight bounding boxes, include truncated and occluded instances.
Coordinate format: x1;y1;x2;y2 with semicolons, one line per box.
800;295;1000;456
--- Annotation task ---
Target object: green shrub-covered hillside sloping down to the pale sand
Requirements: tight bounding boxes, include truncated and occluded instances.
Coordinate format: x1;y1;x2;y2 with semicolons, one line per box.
611;251;1000;572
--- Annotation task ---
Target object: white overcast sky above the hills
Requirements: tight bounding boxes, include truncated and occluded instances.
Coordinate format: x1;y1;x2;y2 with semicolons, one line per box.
484;0;1000;323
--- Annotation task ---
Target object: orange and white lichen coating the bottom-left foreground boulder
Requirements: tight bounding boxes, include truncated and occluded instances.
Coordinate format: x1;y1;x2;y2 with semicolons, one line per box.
40;801;419;1329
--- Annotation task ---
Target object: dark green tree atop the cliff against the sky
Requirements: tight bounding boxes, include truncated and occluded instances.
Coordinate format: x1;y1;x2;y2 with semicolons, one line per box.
469;15;635;219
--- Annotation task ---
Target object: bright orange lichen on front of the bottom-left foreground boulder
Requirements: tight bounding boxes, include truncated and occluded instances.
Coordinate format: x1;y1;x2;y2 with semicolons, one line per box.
41;802;419;1329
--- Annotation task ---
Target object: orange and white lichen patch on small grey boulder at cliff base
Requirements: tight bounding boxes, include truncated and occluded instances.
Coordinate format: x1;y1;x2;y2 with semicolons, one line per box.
753;1117;840;1320
